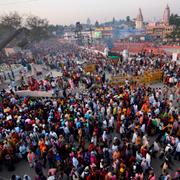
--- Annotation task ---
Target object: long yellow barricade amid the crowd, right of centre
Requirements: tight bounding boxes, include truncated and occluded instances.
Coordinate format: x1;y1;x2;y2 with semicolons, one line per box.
109;70;163;86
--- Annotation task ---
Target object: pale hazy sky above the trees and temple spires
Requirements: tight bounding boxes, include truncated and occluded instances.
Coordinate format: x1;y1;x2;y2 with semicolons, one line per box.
0;0;180;24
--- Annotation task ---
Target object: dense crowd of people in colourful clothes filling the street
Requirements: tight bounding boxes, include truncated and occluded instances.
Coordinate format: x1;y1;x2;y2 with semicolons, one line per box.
0;41;180;180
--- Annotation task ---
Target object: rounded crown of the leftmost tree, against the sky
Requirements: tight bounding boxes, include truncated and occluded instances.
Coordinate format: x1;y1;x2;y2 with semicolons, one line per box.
0;12;23;29
